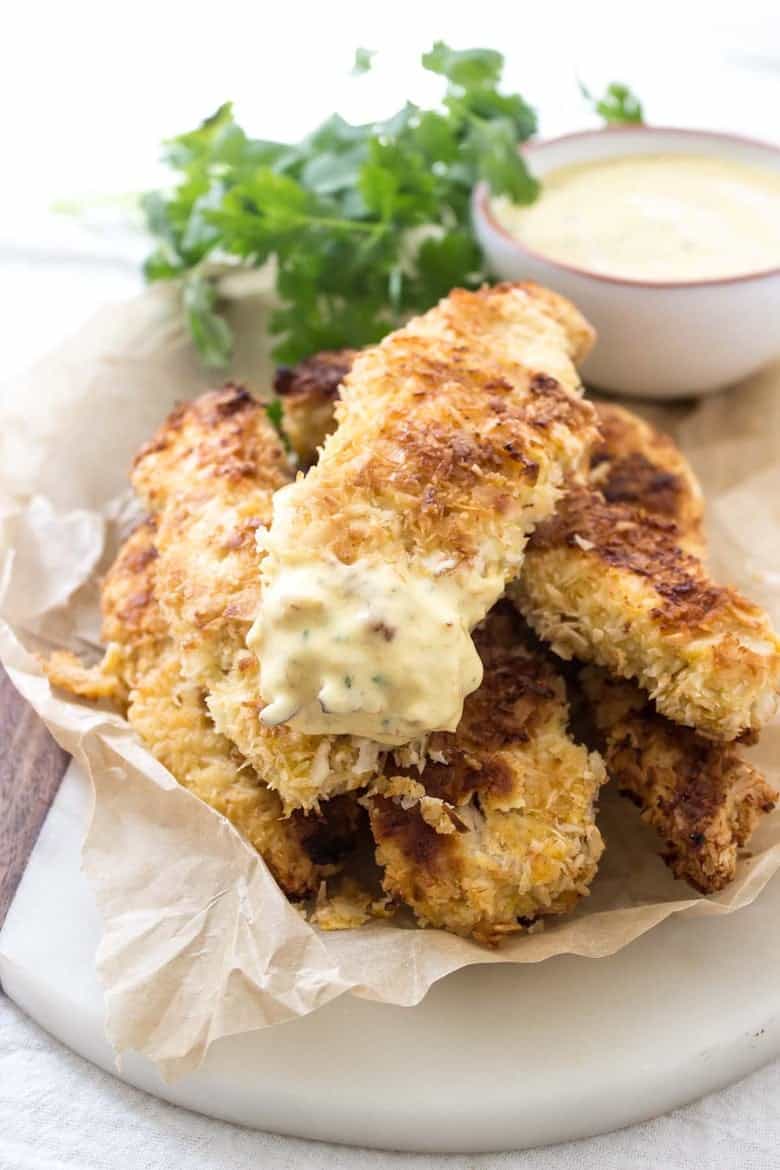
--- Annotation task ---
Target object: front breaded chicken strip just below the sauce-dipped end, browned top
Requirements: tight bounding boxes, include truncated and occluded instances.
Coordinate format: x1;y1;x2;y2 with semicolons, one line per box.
366;606;605;943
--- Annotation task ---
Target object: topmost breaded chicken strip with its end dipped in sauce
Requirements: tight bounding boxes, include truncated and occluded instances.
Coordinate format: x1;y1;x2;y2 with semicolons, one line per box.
256;284;595;744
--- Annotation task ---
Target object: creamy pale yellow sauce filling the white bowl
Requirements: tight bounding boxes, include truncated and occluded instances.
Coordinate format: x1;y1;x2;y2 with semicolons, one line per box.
492;154;780;282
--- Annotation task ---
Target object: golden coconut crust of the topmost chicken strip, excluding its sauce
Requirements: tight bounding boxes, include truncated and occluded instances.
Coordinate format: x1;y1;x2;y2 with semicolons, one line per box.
259;284;595;742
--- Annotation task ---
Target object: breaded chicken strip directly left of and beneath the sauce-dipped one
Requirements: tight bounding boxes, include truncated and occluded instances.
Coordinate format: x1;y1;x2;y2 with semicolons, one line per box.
132;386;380;811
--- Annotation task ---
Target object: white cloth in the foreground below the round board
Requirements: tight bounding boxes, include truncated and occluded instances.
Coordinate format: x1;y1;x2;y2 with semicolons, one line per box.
0;997;780;1170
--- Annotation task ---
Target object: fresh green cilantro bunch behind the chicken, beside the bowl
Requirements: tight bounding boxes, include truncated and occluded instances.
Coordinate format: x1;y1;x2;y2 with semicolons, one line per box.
143;41;538;366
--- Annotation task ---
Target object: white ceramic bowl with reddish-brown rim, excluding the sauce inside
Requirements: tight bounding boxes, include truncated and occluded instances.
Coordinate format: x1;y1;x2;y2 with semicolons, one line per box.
472;126;780;398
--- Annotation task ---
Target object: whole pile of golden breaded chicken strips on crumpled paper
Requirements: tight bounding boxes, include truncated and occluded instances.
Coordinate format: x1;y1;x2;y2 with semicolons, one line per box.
48;284;780;945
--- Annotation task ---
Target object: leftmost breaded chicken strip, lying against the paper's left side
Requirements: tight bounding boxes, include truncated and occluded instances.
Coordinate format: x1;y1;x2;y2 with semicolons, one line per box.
48;519;358;897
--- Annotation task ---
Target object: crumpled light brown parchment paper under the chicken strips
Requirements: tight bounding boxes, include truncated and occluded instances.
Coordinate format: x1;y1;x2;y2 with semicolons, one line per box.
0;274;780;1079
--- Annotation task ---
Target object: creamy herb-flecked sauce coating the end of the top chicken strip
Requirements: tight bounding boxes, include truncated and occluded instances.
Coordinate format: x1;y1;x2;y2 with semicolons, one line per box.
248;558;503;744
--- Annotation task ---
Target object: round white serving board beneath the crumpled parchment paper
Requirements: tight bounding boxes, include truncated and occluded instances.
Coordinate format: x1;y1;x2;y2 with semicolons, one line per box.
0;768;780;1152
